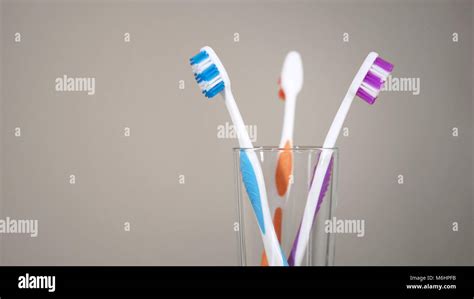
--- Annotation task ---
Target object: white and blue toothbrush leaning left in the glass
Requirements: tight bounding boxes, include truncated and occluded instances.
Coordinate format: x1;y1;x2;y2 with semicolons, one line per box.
190;46;288;266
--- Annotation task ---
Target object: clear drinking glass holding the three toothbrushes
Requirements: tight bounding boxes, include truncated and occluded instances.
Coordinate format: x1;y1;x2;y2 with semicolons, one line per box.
234;146;338;266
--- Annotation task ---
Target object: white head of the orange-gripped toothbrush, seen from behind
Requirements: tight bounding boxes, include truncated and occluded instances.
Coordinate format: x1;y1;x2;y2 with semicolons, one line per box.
279;51;303;99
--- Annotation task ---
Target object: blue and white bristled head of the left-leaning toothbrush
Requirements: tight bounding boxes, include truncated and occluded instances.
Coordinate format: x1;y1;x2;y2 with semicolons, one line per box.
189;46;230;99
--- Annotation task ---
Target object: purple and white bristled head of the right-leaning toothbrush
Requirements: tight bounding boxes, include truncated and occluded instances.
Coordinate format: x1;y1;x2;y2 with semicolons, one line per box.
356;52;393;105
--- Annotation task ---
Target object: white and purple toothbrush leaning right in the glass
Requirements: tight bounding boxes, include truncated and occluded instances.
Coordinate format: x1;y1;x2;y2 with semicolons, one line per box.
288;52;393;266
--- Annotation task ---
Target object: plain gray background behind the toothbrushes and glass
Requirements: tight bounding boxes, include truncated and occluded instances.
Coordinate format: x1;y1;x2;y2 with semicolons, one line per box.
0;1;474;265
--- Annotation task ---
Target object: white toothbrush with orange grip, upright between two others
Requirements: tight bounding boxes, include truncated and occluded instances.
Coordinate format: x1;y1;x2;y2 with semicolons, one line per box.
261;51;303;266
